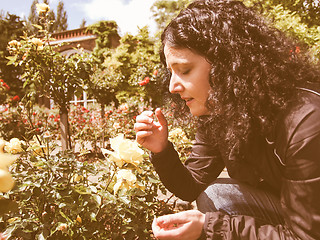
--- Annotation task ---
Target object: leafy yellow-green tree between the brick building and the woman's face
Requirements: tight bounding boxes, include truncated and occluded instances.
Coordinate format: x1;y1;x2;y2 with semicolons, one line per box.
91;27;161;109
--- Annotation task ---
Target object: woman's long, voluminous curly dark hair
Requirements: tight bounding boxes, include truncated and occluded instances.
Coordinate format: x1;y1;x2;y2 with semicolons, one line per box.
160;0;319;150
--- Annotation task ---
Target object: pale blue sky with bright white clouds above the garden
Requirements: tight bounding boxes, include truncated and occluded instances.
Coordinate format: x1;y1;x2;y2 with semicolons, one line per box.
0;0;156;36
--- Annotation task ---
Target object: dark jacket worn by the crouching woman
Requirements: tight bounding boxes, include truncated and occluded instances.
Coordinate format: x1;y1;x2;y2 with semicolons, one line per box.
151;89;320;240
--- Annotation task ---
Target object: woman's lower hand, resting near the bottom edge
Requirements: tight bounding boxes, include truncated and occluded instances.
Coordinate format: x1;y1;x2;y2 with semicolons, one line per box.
152;210;205;240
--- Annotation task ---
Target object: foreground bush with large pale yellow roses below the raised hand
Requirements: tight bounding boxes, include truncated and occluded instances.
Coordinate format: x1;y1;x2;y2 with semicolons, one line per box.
0;132;173;239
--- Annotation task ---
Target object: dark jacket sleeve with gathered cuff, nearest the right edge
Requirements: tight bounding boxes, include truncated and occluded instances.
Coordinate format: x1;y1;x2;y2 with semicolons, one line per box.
204;96;320;240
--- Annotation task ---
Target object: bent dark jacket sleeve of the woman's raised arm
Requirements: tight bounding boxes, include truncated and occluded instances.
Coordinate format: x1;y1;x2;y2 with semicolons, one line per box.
151;128;224;202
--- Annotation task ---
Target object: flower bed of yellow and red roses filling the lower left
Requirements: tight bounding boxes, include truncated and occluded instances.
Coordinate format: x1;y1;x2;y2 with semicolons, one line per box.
0;103;195;239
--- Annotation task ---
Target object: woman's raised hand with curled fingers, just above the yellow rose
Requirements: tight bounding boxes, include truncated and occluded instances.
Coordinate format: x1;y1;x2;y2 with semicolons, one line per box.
134;108;168;153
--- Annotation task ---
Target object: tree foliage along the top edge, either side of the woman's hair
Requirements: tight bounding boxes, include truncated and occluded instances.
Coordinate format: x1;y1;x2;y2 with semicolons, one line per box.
151;0;320;62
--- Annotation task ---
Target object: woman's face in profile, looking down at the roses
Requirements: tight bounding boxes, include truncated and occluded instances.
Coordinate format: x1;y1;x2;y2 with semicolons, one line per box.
164;44;211;116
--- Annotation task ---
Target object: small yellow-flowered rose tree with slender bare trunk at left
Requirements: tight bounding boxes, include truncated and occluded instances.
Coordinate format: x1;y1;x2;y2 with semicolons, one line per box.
7;11;92;150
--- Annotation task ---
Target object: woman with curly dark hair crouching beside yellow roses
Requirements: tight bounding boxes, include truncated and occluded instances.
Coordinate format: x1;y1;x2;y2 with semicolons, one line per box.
134;0;320;239
